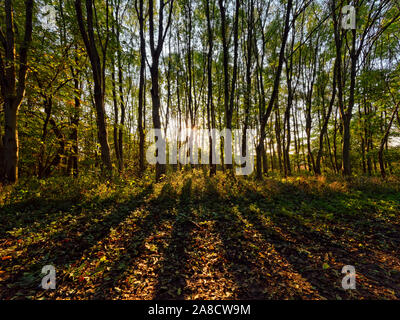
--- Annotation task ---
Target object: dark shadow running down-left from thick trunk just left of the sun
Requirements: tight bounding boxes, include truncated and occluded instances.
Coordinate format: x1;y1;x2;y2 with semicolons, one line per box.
62;183;182;299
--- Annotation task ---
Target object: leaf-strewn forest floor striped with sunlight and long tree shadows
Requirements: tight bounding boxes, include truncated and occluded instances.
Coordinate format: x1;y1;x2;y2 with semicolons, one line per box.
0;171;400;299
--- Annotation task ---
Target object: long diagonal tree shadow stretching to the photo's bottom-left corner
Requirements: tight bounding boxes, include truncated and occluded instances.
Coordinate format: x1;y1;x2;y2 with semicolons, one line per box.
0;187;152;297
